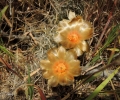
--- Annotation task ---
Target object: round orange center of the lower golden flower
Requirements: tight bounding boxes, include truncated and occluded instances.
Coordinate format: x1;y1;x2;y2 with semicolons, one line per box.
54;61;67;74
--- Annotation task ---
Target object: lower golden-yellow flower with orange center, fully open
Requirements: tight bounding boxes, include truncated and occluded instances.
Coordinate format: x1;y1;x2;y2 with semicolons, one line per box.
40;46;81;87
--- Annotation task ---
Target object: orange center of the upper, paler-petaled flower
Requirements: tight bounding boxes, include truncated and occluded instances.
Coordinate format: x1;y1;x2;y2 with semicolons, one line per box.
67;32;80;43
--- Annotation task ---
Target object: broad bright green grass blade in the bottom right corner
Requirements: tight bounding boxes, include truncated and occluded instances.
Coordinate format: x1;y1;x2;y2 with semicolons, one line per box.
85;66;120;100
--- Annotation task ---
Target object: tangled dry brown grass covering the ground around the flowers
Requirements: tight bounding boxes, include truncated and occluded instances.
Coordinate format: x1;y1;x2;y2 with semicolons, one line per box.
0;0;120;100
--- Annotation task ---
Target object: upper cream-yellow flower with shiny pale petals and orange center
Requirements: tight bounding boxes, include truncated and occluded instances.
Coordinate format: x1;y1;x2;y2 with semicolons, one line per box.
54;12;93;56
